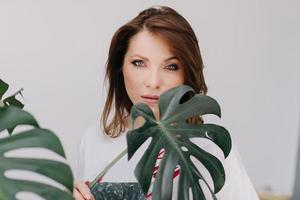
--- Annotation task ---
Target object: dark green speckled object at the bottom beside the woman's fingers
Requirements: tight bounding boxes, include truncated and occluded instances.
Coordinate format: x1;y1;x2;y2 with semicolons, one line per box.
91;182;145;200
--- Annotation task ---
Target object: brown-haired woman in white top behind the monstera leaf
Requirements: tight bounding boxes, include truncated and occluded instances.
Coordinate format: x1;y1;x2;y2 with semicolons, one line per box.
74;6;258;200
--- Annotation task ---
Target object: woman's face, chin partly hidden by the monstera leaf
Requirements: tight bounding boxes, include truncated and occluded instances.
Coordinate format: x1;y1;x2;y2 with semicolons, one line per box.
123;31;184;119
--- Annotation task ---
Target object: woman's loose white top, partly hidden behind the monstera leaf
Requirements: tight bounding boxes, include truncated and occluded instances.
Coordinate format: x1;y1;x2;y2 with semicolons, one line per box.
75;126;259;200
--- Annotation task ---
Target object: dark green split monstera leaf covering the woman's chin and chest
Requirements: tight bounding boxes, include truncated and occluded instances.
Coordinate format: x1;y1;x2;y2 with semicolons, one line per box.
127;85;231;200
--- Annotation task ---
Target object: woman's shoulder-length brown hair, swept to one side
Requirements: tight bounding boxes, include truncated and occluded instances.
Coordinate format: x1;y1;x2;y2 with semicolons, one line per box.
101;6;207;137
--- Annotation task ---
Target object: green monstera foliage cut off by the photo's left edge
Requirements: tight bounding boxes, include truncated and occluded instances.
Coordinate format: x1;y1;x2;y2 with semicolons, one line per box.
0;80;73;200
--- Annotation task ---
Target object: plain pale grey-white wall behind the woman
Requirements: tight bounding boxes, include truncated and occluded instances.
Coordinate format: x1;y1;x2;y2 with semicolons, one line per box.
0;0;300;197
